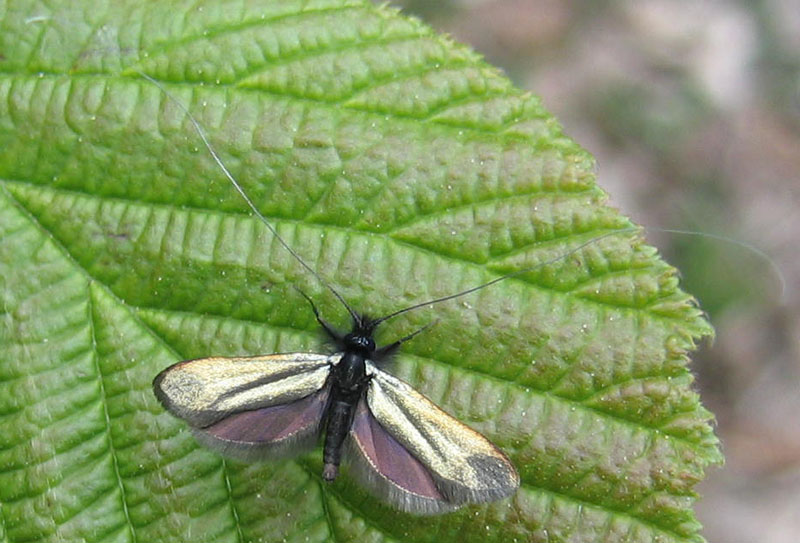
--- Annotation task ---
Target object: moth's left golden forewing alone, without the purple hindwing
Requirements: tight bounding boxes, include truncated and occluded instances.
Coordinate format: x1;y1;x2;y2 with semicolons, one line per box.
153;353;341;428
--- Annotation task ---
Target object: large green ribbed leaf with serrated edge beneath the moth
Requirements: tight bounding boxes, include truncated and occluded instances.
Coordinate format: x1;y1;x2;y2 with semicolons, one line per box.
0;0;721;543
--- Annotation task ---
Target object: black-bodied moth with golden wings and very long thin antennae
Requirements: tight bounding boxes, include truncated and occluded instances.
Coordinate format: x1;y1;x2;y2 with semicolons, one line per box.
145;72;630;514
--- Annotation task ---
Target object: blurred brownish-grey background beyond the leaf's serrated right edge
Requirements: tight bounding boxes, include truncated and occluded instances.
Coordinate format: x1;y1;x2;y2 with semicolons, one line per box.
392;0;800;543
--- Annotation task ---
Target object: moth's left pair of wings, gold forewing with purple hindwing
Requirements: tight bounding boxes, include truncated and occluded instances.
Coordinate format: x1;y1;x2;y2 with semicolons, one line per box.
153;353;341;459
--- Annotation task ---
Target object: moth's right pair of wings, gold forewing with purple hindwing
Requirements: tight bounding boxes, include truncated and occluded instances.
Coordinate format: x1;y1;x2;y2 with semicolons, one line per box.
352;365;519;513
